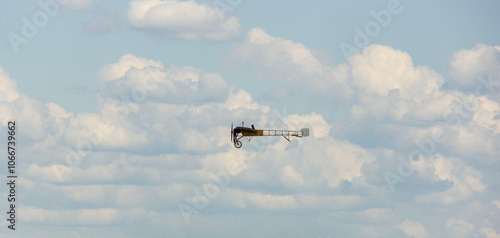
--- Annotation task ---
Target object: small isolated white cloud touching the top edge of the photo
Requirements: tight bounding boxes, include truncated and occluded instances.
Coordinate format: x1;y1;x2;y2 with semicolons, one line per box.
128;0;241;41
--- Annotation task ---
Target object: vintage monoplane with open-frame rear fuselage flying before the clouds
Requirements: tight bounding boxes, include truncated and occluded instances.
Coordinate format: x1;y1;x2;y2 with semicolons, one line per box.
231;122;309;149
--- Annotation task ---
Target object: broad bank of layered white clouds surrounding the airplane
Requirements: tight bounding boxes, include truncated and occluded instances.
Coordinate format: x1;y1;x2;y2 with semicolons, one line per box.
0;40;500;237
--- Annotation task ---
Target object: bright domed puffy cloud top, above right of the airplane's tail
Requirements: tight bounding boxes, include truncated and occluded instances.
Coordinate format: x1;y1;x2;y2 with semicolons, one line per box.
349;45;448;121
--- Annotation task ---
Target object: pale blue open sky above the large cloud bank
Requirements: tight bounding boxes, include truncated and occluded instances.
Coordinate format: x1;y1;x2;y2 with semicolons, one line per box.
1;1;500;112
